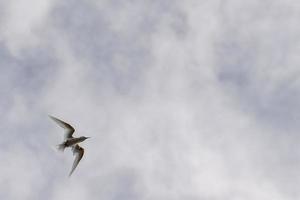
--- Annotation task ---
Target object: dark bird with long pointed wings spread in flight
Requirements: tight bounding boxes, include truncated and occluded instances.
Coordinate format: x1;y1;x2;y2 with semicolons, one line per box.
49;115;90;177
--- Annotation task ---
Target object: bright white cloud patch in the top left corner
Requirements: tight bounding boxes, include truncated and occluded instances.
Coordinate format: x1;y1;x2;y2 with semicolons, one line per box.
0;0;55;55
